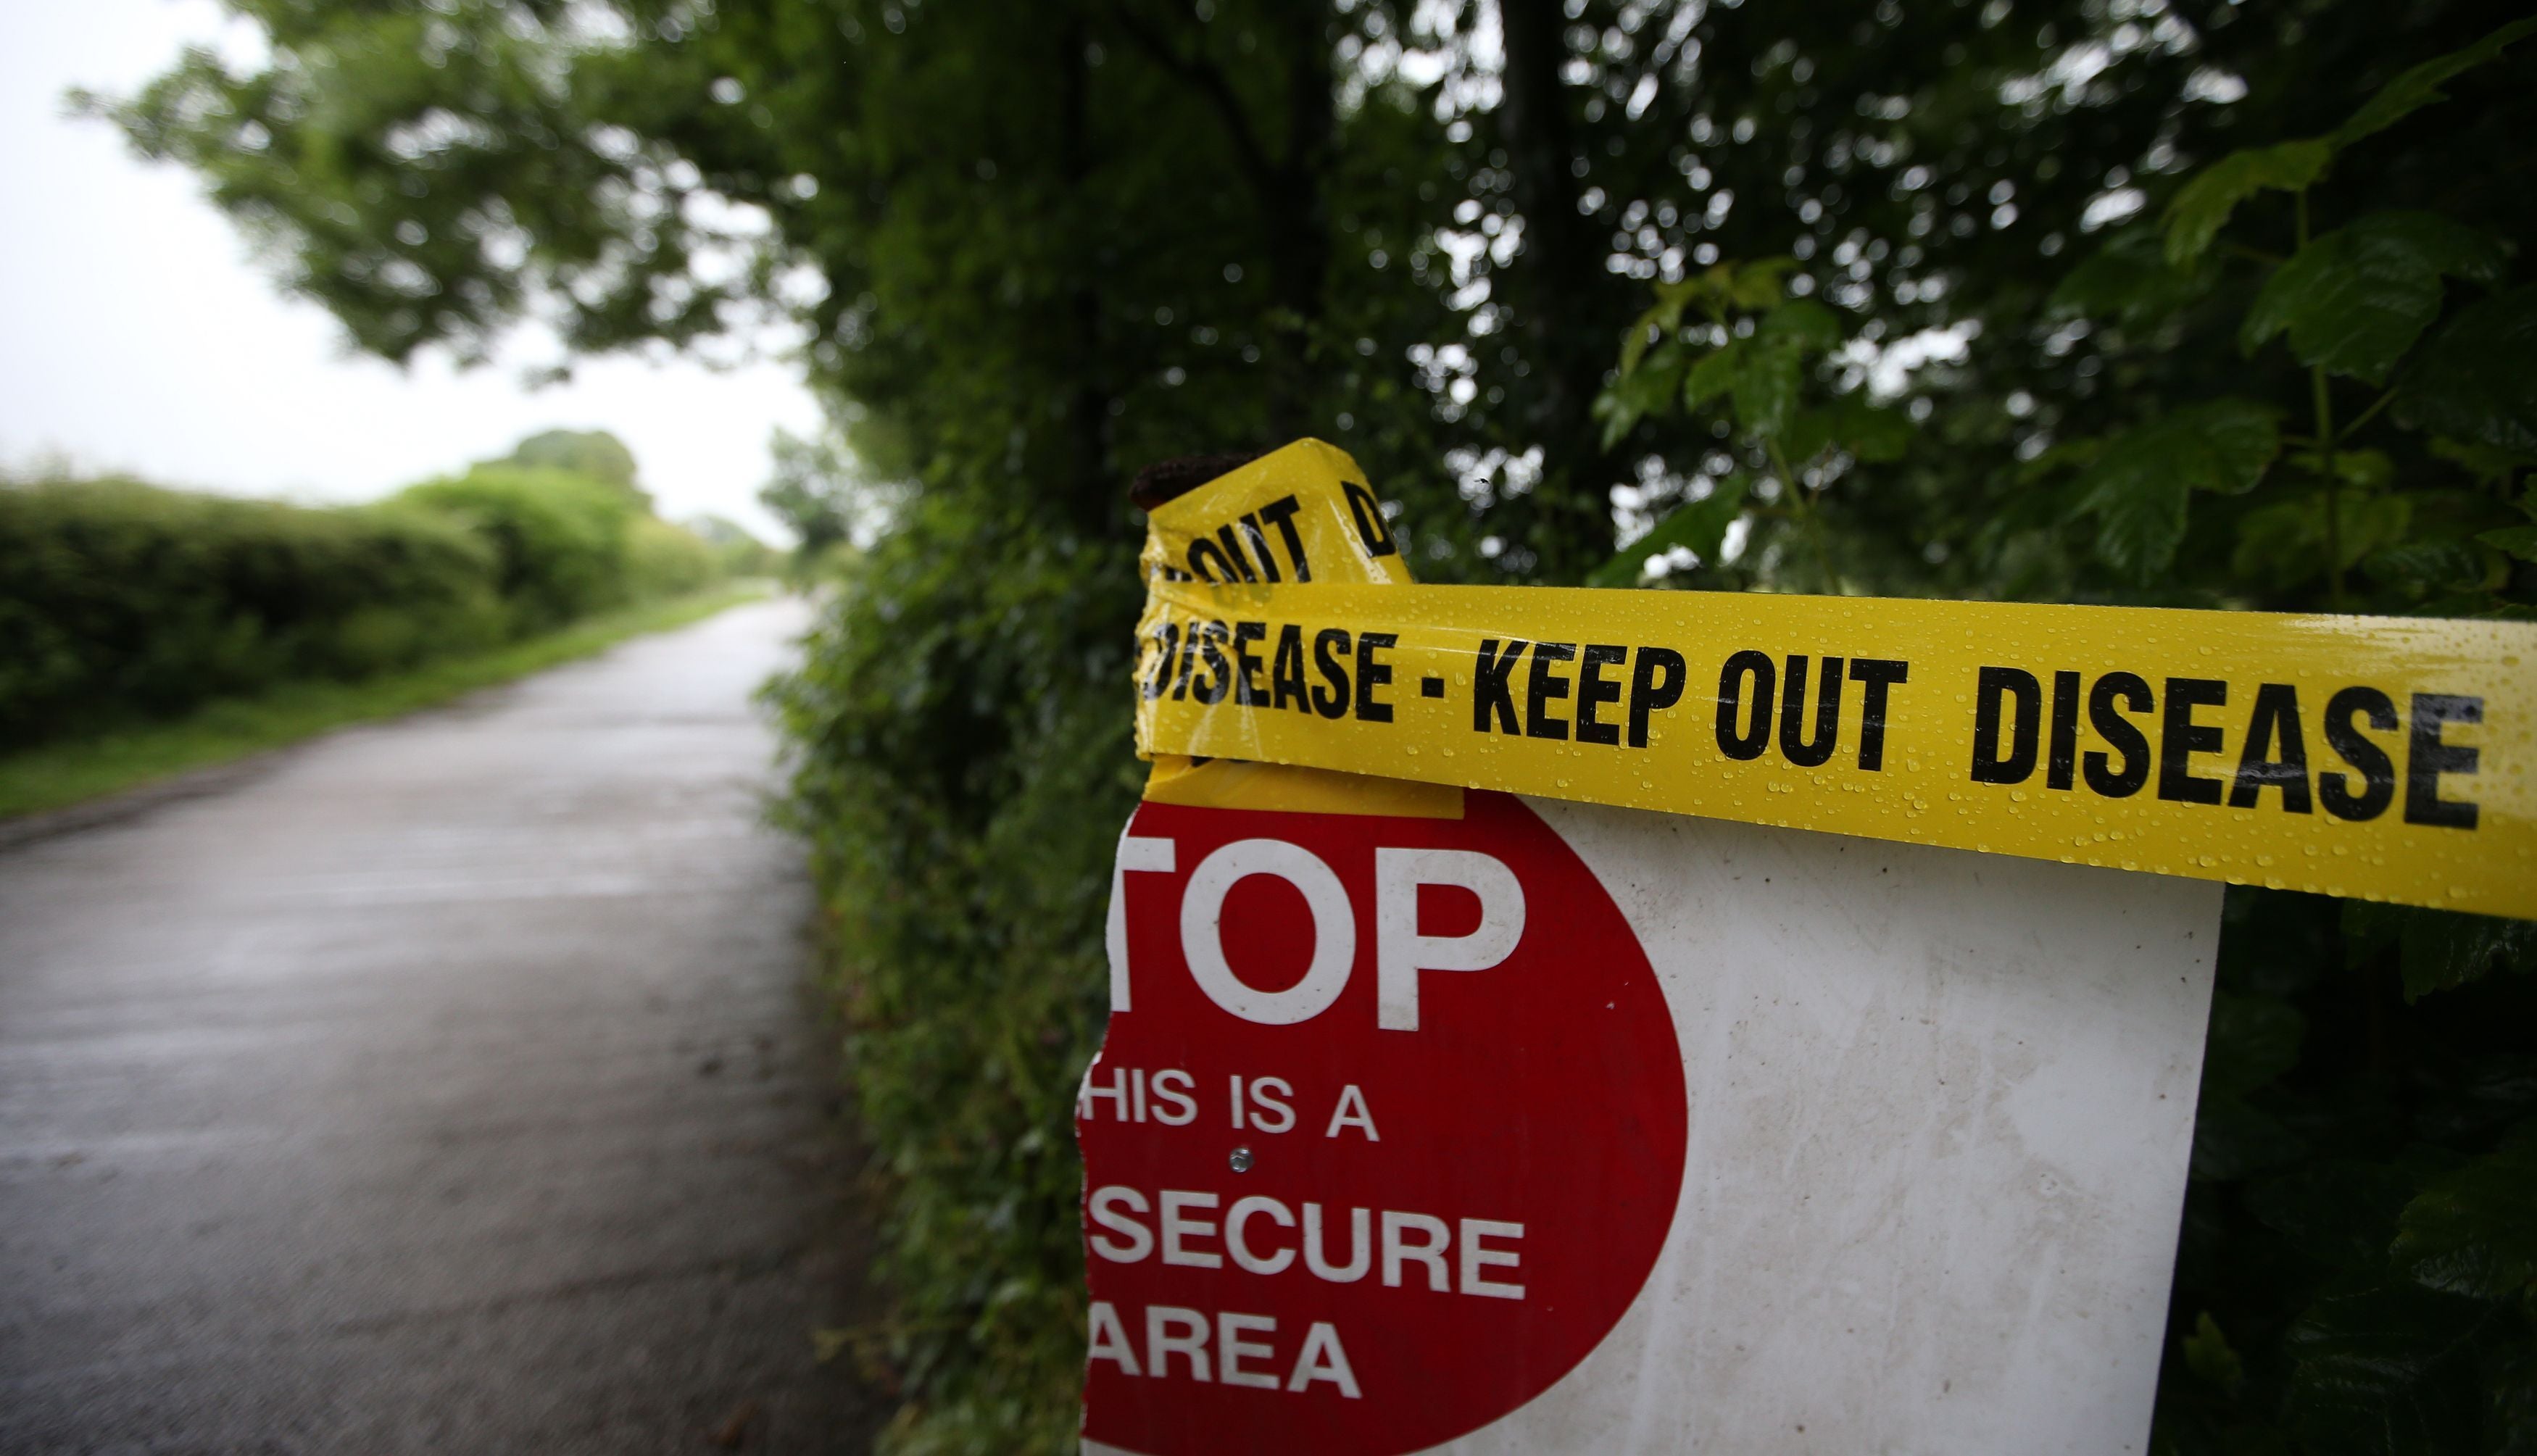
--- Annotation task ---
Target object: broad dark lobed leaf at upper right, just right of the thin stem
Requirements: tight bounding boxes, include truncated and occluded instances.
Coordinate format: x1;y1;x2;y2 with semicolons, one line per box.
2238;213;2507;383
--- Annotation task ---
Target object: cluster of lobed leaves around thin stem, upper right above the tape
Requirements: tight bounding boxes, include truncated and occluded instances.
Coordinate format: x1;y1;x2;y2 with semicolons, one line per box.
2038;20;2537;614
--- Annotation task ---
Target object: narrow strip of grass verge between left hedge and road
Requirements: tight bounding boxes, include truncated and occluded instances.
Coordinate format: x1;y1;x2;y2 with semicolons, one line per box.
0;583;769;820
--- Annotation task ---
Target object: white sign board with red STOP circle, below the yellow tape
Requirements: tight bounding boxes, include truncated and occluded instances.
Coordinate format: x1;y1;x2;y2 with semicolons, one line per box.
1079;791;2222;1456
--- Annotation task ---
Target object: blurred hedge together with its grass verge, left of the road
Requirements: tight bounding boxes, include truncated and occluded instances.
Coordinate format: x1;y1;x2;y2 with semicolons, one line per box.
0;431;774;817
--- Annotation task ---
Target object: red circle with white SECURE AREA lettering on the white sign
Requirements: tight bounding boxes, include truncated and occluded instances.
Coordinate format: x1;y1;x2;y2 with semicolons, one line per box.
1076;794;1685;1456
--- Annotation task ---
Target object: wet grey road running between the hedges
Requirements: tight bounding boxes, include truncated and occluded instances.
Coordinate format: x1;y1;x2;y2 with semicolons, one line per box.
0;604;886;1454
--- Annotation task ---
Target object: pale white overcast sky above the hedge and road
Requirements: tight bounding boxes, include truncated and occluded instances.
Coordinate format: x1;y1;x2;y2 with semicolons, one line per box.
0;0;820;536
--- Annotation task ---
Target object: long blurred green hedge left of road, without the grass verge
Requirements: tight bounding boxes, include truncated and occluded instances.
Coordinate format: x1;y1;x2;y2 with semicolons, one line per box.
0;467;718;746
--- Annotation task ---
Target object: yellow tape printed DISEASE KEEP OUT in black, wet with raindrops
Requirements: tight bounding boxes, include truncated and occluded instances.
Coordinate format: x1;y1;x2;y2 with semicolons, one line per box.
1137;444;2537;918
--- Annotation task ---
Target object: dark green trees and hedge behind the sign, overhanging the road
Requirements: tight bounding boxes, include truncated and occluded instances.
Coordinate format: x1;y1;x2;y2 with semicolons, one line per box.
91;0;2537;1451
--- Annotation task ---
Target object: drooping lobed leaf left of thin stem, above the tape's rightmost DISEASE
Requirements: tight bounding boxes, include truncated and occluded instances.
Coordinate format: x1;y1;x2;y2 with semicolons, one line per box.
2075;399;2281;583
